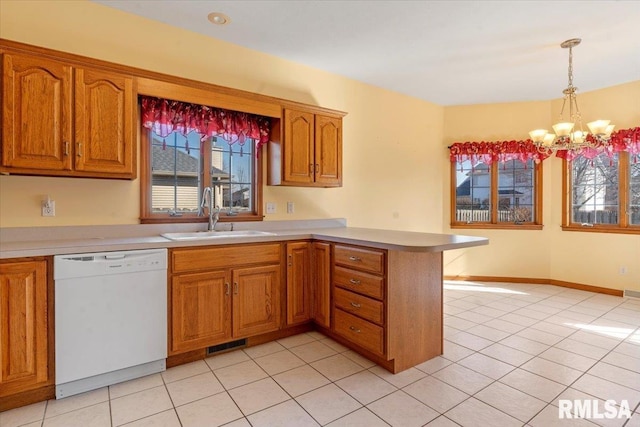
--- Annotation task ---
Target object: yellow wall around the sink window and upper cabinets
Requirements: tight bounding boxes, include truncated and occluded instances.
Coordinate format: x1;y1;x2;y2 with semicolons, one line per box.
0;0;444;232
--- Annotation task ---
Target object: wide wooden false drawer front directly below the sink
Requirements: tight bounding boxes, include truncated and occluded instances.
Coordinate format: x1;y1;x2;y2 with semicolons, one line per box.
171;244;280;273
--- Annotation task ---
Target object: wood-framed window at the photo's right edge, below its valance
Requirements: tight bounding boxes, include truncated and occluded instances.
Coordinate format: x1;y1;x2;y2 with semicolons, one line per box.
563;151;640;233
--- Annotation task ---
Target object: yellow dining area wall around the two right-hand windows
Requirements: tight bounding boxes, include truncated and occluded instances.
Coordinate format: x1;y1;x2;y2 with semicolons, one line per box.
443;81;640;290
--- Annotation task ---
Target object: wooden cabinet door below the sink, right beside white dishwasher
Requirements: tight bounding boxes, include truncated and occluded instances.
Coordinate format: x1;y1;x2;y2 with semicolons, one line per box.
171;270;231;354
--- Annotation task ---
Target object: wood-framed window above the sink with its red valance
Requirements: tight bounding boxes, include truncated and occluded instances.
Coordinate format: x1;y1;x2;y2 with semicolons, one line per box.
140;98;268;223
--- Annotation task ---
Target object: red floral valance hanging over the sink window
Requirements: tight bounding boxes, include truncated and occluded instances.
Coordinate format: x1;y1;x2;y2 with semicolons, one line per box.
140;96;271;152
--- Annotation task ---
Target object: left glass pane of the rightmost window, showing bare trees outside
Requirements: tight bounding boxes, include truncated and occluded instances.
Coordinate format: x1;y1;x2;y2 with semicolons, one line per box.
571;154;619;224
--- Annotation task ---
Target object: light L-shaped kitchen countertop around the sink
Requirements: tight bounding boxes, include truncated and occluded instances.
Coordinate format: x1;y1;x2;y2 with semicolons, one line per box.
0;219;489;259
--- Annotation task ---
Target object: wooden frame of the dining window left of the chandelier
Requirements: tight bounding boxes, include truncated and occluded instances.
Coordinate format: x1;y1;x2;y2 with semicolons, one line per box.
449;161;543;230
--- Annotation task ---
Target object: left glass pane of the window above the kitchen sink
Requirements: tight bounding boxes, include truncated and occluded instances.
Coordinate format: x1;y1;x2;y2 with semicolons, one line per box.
150;132;202;213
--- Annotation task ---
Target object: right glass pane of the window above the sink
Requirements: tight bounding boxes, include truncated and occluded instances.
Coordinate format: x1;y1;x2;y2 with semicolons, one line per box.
211;138;256;213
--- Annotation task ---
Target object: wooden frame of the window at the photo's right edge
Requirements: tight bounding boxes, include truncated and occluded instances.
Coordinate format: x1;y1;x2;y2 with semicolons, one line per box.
562;151;640;234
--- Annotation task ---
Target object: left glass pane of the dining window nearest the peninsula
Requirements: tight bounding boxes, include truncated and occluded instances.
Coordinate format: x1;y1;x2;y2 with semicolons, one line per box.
455;161;491;222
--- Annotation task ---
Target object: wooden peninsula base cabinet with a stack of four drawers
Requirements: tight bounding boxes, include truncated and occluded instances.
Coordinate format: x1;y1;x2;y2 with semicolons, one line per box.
331;244;443;373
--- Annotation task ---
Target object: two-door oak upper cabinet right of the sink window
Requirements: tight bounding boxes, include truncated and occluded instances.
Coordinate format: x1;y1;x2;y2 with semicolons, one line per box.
269;108;342;187
